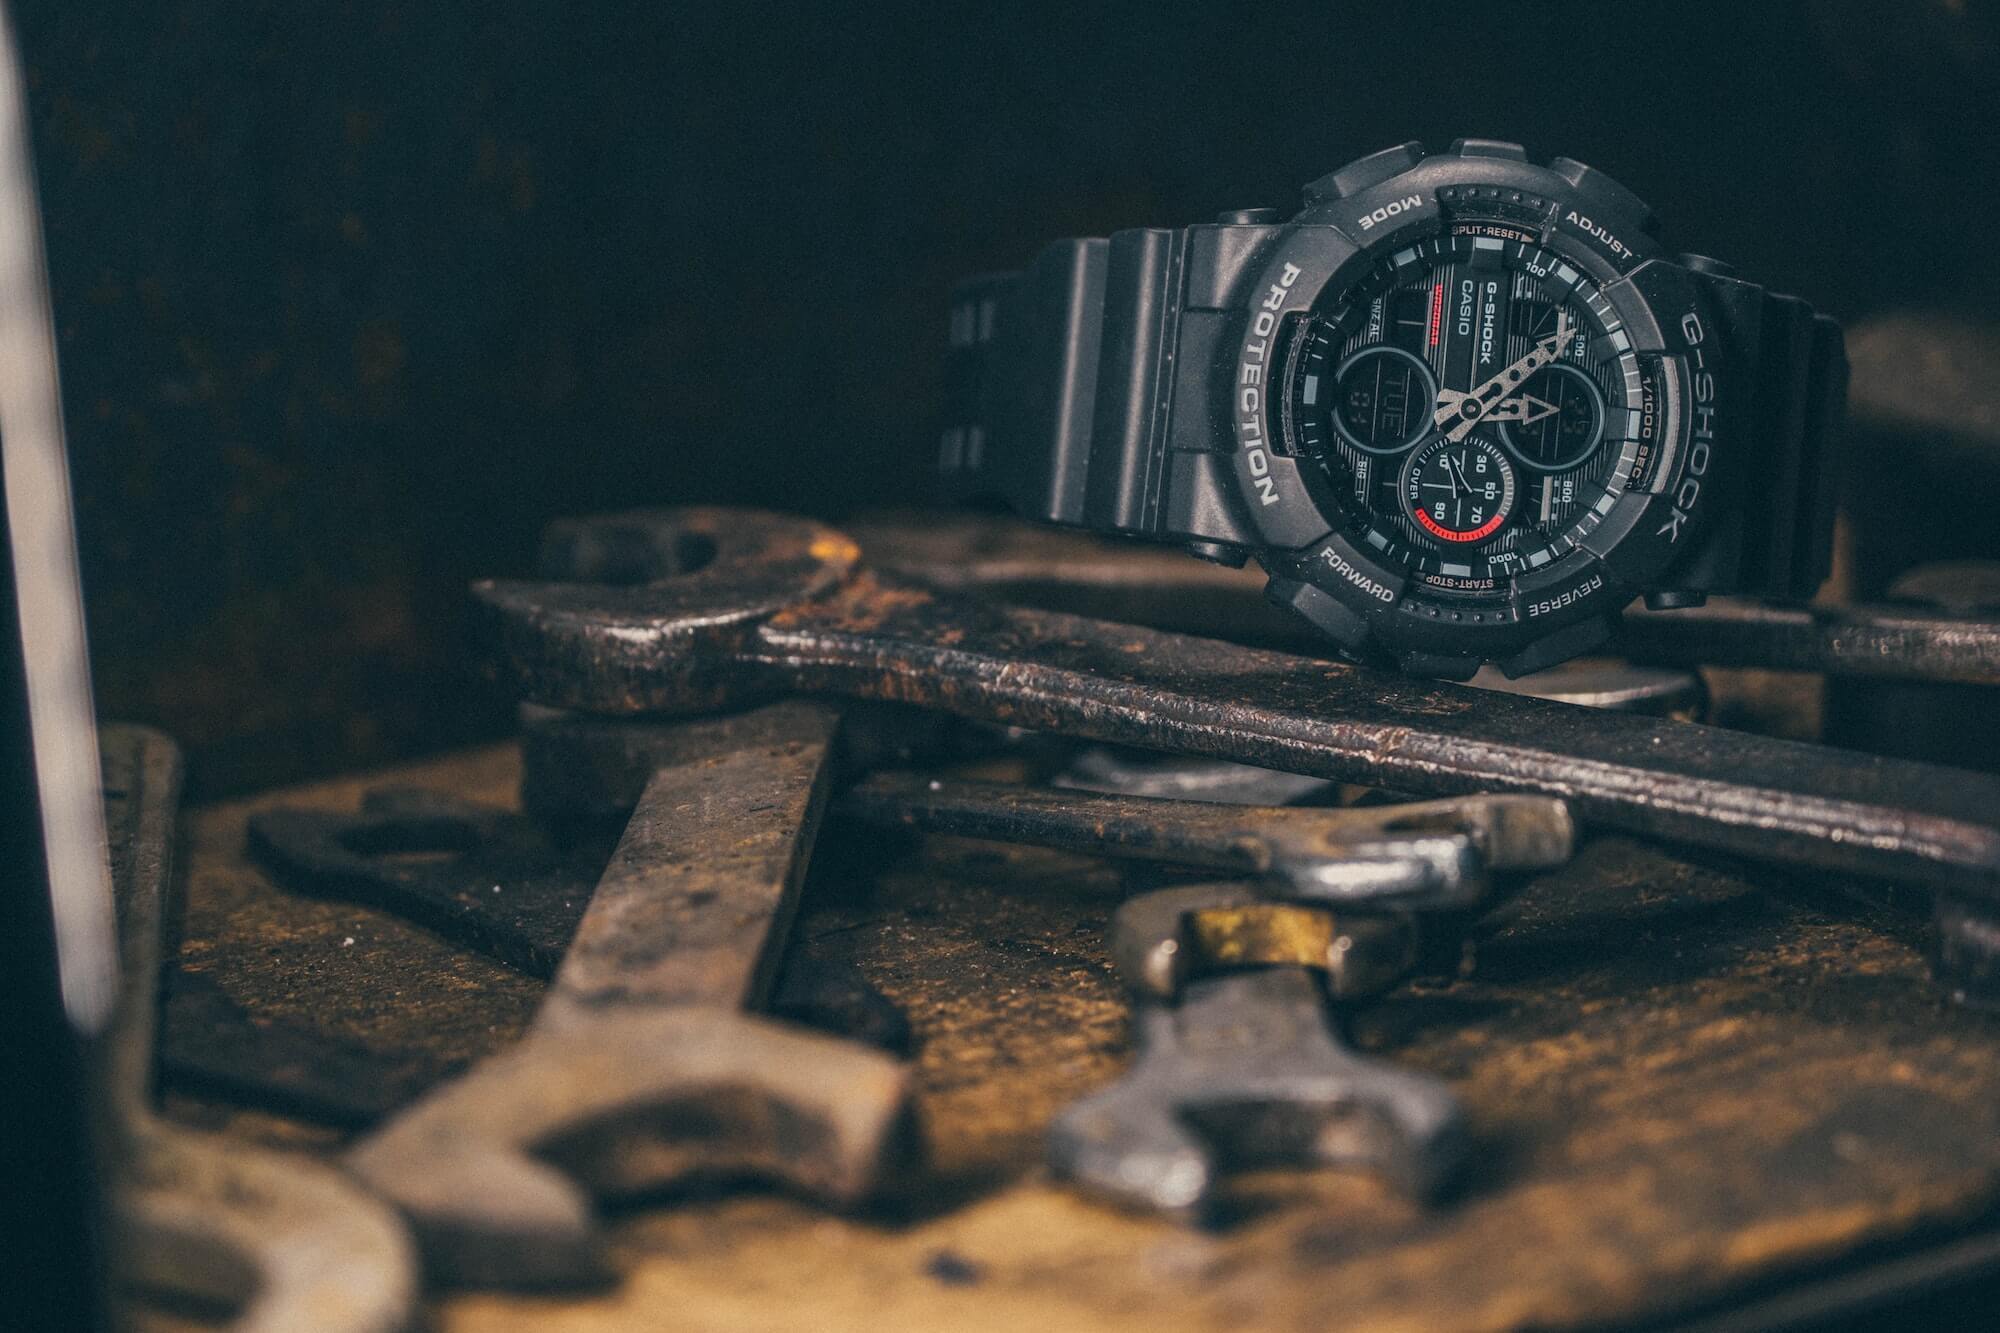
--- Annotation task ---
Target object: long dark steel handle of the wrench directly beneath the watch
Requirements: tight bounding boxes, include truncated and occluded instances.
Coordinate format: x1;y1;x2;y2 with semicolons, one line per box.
744;578;2000;899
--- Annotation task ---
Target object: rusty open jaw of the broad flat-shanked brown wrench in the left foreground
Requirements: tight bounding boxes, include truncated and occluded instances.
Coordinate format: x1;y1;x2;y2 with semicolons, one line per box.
348;1005;918;1289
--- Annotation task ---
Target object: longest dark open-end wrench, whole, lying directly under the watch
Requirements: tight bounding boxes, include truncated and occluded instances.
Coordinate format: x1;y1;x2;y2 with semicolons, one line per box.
474;508;2000;899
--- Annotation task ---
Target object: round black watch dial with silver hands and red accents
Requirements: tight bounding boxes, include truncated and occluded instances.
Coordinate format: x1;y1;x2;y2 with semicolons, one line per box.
1284;220;1658;596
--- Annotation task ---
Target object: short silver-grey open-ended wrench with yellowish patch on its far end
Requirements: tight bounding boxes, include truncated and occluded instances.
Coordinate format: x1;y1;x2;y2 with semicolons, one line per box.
1048;885;1468;1219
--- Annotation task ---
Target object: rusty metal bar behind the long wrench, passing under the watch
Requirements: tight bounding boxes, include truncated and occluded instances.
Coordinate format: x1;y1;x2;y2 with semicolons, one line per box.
850;514;2000;689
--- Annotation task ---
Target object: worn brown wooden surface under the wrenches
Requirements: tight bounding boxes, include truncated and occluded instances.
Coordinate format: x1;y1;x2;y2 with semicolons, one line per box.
152;747;2000;1333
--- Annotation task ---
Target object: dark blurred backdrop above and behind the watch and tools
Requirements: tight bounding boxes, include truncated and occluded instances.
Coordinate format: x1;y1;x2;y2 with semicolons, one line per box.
14;0;2000;793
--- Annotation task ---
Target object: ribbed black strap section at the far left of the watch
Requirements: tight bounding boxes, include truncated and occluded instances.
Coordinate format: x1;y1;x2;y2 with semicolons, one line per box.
938;228;1186;536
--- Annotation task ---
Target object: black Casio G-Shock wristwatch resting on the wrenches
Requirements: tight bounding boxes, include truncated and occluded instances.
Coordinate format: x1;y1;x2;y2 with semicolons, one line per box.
940;138;1846;679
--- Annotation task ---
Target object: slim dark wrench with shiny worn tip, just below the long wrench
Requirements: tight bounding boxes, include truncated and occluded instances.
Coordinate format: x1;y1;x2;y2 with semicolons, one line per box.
516;711;1576;909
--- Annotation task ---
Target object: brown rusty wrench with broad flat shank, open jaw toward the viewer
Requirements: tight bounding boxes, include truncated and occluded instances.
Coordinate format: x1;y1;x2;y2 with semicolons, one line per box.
348;703;914;1287
